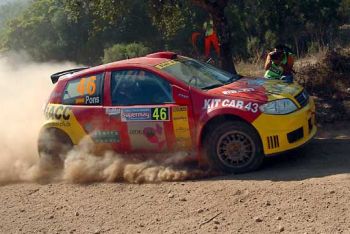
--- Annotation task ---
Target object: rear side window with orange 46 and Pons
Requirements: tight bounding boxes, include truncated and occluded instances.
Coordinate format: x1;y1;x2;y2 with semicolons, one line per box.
62;73;103;105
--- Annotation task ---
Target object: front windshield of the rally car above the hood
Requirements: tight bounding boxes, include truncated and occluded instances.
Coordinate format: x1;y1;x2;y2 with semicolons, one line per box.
156;56;239;90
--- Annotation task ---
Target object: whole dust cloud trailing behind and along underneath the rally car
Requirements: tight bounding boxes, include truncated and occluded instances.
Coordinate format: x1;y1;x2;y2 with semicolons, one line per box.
0;53;208;185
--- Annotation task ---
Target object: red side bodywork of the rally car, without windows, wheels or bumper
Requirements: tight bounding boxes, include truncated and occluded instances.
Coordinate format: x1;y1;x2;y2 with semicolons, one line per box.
42;52;316;162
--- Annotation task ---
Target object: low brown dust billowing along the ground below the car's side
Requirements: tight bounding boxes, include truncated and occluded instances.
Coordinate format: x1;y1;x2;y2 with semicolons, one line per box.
62;141;207;183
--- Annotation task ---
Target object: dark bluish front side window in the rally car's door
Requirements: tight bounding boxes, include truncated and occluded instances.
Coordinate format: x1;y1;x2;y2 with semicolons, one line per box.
111;70;173;106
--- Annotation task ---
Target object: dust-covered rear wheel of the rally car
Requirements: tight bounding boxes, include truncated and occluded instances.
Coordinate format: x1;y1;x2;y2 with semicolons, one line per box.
38;128;73;168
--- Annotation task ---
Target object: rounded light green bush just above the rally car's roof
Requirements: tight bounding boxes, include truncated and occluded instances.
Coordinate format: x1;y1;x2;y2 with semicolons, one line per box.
102;43;150;63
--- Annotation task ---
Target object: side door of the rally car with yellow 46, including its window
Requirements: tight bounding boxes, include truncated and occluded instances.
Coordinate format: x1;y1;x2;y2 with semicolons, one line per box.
105;69;192;152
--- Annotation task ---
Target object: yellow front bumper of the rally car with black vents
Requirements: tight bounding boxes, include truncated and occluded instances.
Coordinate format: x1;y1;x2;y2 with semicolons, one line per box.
253;98;317;156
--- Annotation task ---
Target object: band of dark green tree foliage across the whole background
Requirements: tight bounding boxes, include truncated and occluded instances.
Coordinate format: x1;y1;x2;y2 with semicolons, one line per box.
0;0;350;65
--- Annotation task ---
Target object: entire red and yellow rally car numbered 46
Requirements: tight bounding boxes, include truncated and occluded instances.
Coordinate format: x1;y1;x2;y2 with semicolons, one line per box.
39;52;316;173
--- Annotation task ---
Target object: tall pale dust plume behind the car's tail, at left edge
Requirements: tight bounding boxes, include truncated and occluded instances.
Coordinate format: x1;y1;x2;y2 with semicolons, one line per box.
0;53;74;184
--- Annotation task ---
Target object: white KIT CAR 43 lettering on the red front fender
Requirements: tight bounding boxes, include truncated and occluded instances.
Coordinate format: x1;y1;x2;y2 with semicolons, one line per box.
203;99;259;113
